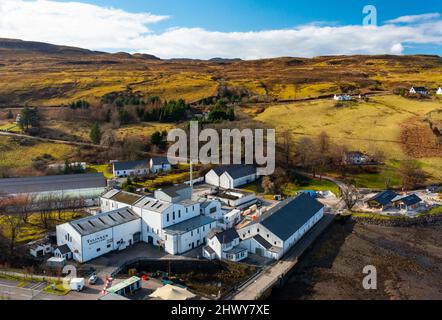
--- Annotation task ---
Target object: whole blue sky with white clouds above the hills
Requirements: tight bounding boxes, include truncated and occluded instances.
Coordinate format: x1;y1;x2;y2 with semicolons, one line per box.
0;0;442;59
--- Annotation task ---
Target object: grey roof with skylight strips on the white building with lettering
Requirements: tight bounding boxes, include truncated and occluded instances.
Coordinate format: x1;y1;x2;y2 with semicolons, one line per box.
69;208;140;236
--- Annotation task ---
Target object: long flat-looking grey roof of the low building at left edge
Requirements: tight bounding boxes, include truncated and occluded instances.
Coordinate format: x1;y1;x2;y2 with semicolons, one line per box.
0;173;106;194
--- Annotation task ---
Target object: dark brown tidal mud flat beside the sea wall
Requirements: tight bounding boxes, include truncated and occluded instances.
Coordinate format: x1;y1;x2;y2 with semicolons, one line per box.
270;220;442;300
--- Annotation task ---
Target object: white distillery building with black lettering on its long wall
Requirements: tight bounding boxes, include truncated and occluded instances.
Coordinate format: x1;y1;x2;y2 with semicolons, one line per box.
57;208;141;263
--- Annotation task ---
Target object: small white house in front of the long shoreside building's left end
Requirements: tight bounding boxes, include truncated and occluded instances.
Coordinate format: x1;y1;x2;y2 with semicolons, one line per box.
203;229;248;262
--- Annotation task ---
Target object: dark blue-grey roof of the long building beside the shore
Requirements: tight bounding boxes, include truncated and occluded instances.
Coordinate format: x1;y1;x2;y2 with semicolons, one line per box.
261;194;324;241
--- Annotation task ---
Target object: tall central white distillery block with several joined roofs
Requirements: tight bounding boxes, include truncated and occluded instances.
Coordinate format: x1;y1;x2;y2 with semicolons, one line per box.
101;184;222;254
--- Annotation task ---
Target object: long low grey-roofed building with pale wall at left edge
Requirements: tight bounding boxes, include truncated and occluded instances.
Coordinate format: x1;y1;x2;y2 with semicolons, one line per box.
0;173;107;205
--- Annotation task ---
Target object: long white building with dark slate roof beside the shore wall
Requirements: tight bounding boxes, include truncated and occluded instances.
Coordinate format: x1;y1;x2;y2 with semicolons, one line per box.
238;194;324;260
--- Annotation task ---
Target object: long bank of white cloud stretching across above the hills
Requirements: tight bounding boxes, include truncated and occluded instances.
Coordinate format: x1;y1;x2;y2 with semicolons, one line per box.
0;0;442;59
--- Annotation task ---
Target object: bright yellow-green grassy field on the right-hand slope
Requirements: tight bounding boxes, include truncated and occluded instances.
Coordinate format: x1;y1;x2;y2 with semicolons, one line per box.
255;95;442;181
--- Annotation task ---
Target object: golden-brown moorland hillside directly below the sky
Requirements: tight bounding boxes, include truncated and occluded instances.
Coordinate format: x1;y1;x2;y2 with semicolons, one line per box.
0;39;442;107
